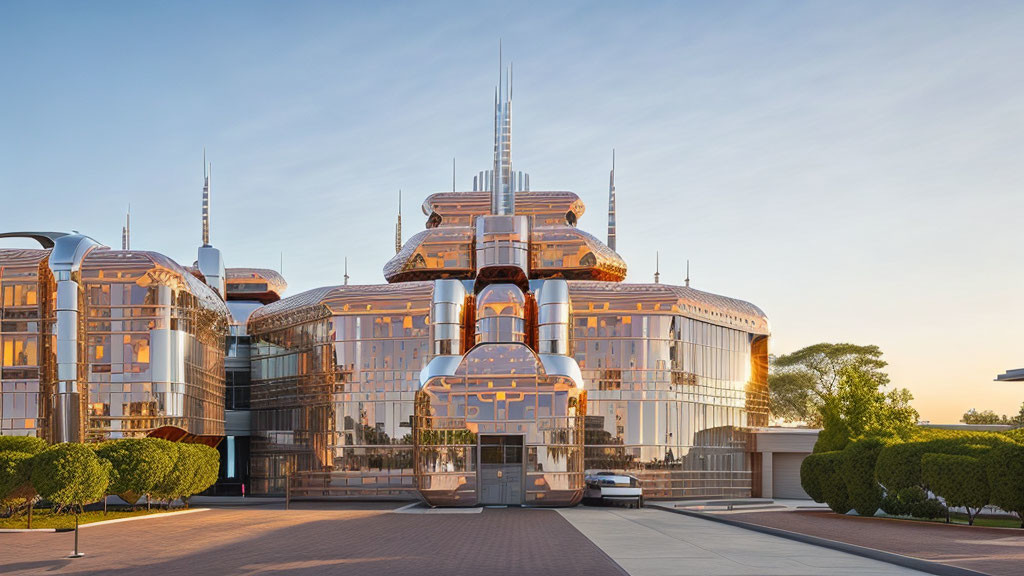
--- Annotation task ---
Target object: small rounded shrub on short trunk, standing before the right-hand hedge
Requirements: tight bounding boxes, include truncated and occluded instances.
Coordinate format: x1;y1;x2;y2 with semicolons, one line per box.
921;454;989;525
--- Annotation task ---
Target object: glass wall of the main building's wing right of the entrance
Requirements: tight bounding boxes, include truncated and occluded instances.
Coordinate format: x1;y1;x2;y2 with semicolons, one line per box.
570;283;767;497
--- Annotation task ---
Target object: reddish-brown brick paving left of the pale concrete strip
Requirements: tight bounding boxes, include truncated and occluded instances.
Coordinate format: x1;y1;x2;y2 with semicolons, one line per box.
0;502;625;576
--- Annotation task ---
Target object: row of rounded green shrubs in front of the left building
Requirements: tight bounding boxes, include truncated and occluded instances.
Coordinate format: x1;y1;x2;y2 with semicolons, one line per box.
0;437;220;512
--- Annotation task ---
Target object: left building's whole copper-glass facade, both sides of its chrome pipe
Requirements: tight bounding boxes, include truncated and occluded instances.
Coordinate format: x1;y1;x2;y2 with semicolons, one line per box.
0;248;227;441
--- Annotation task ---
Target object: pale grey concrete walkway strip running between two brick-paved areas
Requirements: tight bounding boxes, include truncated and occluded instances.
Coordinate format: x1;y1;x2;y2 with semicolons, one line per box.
558;507;921;576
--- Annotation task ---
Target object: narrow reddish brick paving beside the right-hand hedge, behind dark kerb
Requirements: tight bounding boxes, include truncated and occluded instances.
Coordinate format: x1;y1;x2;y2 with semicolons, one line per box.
729;511;1024;576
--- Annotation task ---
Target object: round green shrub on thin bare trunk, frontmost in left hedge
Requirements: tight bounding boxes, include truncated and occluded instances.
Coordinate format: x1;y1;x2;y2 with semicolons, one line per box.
32;443;110;506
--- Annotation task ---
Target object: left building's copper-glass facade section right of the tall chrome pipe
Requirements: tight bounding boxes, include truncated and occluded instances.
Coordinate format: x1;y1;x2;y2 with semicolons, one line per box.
82;250;227;441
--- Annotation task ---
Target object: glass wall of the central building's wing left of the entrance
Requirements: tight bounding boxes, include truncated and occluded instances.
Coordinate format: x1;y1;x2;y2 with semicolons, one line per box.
249;282;433;497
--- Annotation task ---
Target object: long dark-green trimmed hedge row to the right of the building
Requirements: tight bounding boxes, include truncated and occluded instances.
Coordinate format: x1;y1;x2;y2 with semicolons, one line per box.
800;428;1024;526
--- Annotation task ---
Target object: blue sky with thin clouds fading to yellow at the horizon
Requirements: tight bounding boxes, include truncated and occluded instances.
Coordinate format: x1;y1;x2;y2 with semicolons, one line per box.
0;0;1024;421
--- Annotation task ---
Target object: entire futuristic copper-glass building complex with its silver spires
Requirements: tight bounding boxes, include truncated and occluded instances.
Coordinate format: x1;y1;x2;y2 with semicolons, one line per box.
0;60;769;505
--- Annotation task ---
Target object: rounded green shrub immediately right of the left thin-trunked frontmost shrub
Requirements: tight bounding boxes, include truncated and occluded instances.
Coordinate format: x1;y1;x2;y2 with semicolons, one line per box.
96;438;174;504
